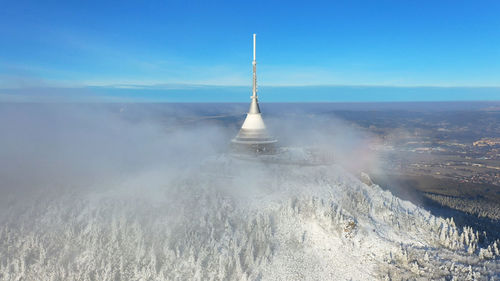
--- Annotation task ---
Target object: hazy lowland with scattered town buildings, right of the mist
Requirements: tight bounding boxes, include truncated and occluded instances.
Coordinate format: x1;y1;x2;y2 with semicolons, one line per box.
326;108;500;220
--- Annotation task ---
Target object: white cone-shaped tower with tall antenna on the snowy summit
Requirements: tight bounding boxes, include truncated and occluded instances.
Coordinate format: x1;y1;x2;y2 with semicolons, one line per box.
231;34;278;154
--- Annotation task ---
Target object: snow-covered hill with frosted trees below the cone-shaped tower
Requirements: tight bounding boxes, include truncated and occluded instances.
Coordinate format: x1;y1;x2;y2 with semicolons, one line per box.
0;149;500;280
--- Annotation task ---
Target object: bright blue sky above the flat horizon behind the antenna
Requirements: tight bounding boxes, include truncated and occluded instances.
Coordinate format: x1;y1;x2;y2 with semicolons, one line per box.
0;0;500;101
